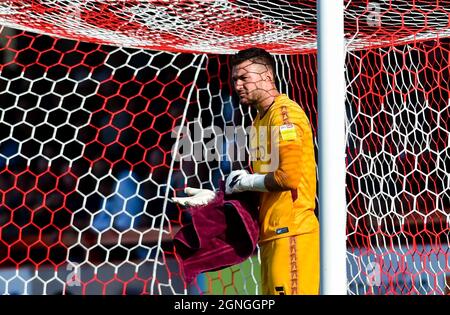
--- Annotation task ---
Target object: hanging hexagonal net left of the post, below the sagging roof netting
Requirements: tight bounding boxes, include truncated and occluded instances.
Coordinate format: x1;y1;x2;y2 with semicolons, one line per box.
0;27;316;294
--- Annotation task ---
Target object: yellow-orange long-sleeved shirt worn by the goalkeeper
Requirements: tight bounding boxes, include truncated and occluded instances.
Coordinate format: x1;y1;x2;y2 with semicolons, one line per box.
250;94;317;242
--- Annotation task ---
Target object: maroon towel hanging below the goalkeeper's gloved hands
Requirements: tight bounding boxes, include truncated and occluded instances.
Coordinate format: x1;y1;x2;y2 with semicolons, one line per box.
174;183;259;283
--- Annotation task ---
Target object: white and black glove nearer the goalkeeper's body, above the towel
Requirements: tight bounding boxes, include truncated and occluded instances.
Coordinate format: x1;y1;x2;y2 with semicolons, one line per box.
225;170;268;194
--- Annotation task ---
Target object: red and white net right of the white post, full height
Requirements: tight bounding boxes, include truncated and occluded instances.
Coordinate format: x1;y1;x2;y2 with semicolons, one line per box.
345;1;450;294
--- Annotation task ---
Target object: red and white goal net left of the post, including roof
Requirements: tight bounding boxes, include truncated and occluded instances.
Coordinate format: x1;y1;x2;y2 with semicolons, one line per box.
0;0;316;294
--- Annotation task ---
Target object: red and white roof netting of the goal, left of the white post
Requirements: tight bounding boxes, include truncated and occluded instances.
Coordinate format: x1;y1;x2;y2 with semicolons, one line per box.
0;0;315;53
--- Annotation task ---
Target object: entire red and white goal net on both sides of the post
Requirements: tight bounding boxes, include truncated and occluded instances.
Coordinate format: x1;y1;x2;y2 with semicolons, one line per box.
0;0;450;294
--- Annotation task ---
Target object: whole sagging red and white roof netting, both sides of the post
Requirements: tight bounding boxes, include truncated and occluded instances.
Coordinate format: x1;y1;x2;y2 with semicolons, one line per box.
0;0;450;54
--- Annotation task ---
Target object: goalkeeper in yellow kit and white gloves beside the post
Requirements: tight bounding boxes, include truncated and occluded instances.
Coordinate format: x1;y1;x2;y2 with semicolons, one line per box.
174;48;320;294
